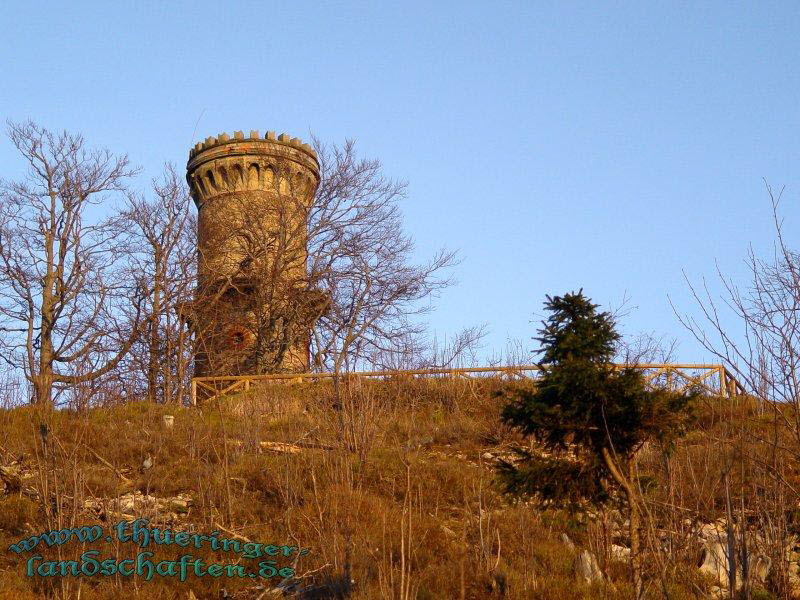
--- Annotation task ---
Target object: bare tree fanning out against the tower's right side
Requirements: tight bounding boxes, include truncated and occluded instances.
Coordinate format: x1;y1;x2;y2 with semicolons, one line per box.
308;139;456;372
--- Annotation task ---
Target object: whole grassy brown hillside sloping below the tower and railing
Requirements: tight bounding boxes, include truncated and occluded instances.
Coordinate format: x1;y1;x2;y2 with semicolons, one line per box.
0;378;797;600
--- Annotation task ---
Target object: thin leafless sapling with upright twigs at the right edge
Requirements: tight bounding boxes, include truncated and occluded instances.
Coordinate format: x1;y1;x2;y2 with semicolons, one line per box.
673;185;800;594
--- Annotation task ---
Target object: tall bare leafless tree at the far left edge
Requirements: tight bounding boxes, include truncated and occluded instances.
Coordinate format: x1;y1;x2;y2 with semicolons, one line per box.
0;122;142;405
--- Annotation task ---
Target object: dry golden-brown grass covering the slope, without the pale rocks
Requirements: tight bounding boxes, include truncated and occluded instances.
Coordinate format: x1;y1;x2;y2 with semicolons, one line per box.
0;379;792;600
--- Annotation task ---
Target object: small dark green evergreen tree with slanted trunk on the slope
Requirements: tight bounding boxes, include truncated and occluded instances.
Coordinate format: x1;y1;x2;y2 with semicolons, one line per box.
499;290;698;598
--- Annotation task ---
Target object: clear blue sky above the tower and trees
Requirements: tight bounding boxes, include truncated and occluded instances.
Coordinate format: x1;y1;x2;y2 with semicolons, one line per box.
0;1;800;362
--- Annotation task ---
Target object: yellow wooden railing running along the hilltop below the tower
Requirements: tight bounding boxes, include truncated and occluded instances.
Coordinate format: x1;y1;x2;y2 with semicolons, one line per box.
192;363;745;404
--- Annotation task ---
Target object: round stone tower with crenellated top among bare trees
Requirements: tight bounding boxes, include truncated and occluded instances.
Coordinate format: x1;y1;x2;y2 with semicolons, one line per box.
186;131;325;376
